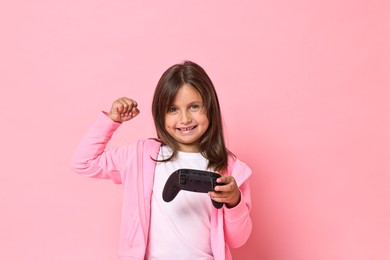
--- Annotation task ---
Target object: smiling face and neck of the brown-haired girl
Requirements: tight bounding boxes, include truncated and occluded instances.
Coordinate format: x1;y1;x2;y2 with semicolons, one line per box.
165;84;209;152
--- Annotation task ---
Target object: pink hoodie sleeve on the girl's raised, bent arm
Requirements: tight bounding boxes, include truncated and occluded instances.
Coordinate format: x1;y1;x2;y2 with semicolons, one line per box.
70;113;136;184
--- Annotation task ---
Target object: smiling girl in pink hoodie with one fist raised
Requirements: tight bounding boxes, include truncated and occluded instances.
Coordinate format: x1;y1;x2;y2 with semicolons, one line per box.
72;61;252;260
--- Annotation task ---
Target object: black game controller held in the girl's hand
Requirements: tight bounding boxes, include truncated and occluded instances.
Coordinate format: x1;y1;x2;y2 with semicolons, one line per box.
163;169;223;209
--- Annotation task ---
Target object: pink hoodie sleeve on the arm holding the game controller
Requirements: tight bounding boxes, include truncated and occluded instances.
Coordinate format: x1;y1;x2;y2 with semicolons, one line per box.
223;160;252;248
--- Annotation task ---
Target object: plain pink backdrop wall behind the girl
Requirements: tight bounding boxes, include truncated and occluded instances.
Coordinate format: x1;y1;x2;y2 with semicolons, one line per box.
0;0;390;260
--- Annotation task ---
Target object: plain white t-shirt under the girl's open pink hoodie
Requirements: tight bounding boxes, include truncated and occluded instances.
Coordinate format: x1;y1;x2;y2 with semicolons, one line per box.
146;146;214;260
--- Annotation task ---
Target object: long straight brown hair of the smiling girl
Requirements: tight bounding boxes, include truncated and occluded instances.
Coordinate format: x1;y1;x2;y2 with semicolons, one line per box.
152;61;234;172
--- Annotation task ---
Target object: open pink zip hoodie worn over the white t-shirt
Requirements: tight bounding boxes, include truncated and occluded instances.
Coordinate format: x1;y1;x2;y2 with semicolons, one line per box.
71;113;252;260
